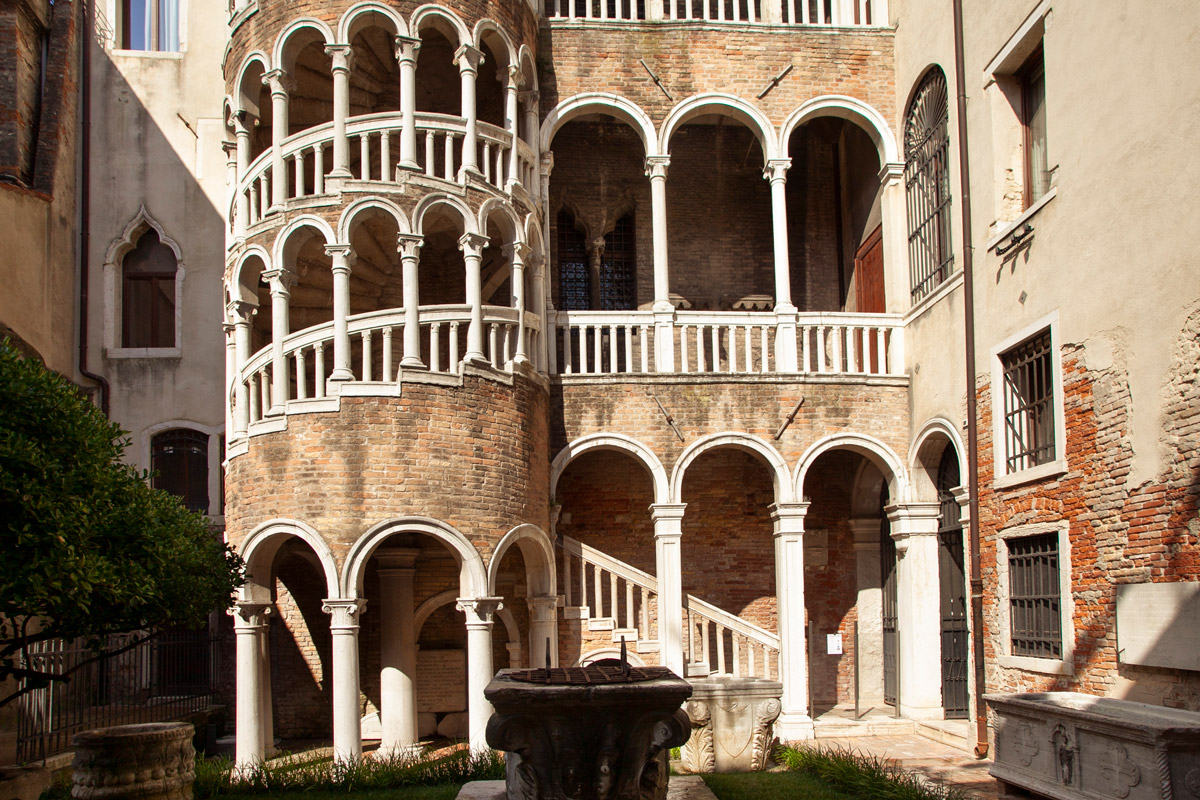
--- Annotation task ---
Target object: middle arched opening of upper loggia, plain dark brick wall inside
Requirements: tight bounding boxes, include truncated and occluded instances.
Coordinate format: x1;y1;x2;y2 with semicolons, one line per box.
667;114;775;311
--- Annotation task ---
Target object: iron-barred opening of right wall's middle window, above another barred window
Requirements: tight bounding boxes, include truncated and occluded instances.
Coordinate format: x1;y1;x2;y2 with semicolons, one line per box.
1000;330;1056;474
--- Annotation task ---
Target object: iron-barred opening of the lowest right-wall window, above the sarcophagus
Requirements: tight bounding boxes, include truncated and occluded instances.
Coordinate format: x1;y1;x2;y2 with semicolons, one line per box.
1007;533;1062;658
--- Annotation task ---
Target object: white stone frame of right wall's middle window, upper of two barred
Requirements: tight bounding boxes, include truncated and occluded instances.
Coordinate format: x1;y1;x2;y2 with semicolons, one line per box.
991;311;1067;489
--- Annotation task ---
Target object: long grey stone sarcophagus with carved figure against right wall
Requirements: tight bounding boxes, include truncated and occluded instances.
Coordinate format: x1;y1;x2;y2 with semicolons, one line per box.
986;692;1200;800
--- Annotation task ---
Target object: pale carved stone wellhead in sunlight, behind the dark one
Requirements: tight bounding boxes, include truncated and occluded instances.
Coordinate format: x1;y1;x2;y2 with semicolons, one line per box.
682;678;784;772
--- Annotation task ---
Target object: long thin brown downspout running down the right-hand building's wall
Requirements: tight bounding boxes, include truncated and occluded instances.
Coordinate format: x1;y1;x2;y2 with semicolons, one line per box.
954;0;988;758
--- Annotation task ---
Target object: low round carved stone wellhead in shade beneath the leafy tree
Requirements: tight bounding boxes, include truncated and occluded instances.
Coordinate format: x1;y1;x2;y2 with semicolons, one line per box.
71;722;196;800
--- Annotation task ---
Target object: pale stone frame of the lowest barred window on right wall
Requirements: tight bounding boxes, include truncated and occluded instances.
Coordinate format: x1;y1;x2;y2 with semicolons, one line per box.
996;521;1075;675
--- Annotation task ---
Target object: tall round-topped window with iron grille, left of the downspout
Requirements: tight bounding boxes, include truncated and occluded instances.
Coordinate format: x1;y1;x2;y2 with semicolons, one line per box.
904;67;954;302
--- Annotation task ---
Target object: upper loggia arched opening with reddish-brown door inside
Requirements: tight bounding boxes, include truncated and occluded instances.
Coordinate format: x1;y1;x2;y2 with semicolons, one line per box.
786;116;886;314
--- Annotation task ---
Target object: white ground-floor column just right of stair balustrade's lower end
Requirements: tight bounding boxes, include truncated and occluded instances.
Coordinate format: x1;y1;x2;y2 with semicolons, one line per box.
770;503;814;741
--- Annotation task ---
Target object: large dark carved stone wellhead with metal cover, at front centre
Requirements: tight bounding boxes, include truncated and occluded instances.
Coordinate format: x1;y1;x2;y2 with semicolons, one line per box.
484;664;691;800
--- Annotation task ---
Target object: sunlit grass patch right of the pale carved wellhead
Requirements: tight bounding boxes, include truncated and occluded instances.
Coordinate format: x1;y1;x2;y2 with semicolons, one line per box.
775;746;966;800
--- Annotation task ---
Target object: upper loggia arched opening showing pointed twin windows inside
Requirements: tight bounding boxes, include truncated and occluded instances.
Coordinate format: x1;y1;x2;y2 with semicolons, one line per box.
550;114;654;311
